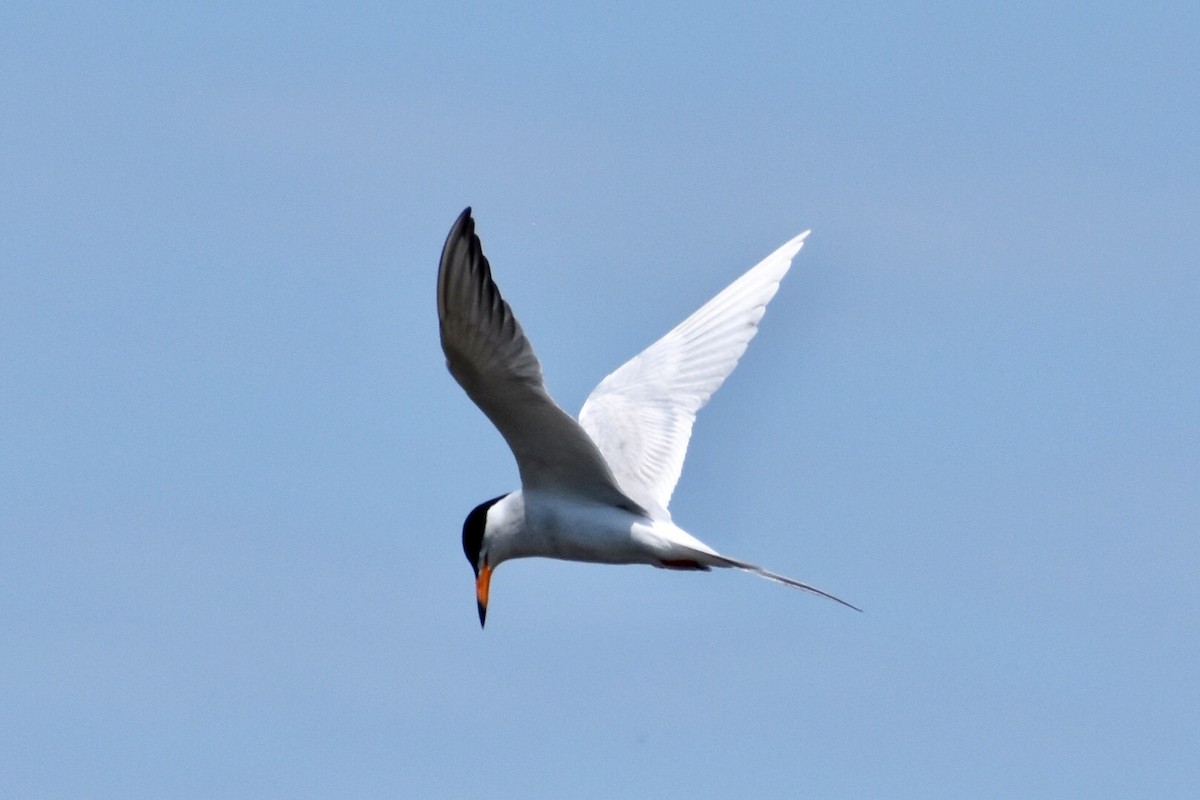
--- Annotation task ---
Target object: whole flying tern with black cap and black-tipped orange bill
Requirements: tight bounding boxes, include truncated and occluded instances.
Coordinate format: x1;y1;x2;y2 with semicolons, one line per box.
438;207;862;626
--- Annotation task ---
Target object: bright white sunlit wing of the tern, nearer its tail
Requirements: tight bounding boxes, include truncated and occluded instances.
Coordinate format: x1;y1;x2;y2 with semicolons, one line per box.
580;231;809;519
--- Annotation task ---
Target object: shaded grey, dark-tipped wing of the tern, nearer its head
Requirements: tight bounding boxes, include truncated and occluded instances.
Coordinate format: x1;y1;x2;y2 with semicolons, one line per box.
438;209;641;511
